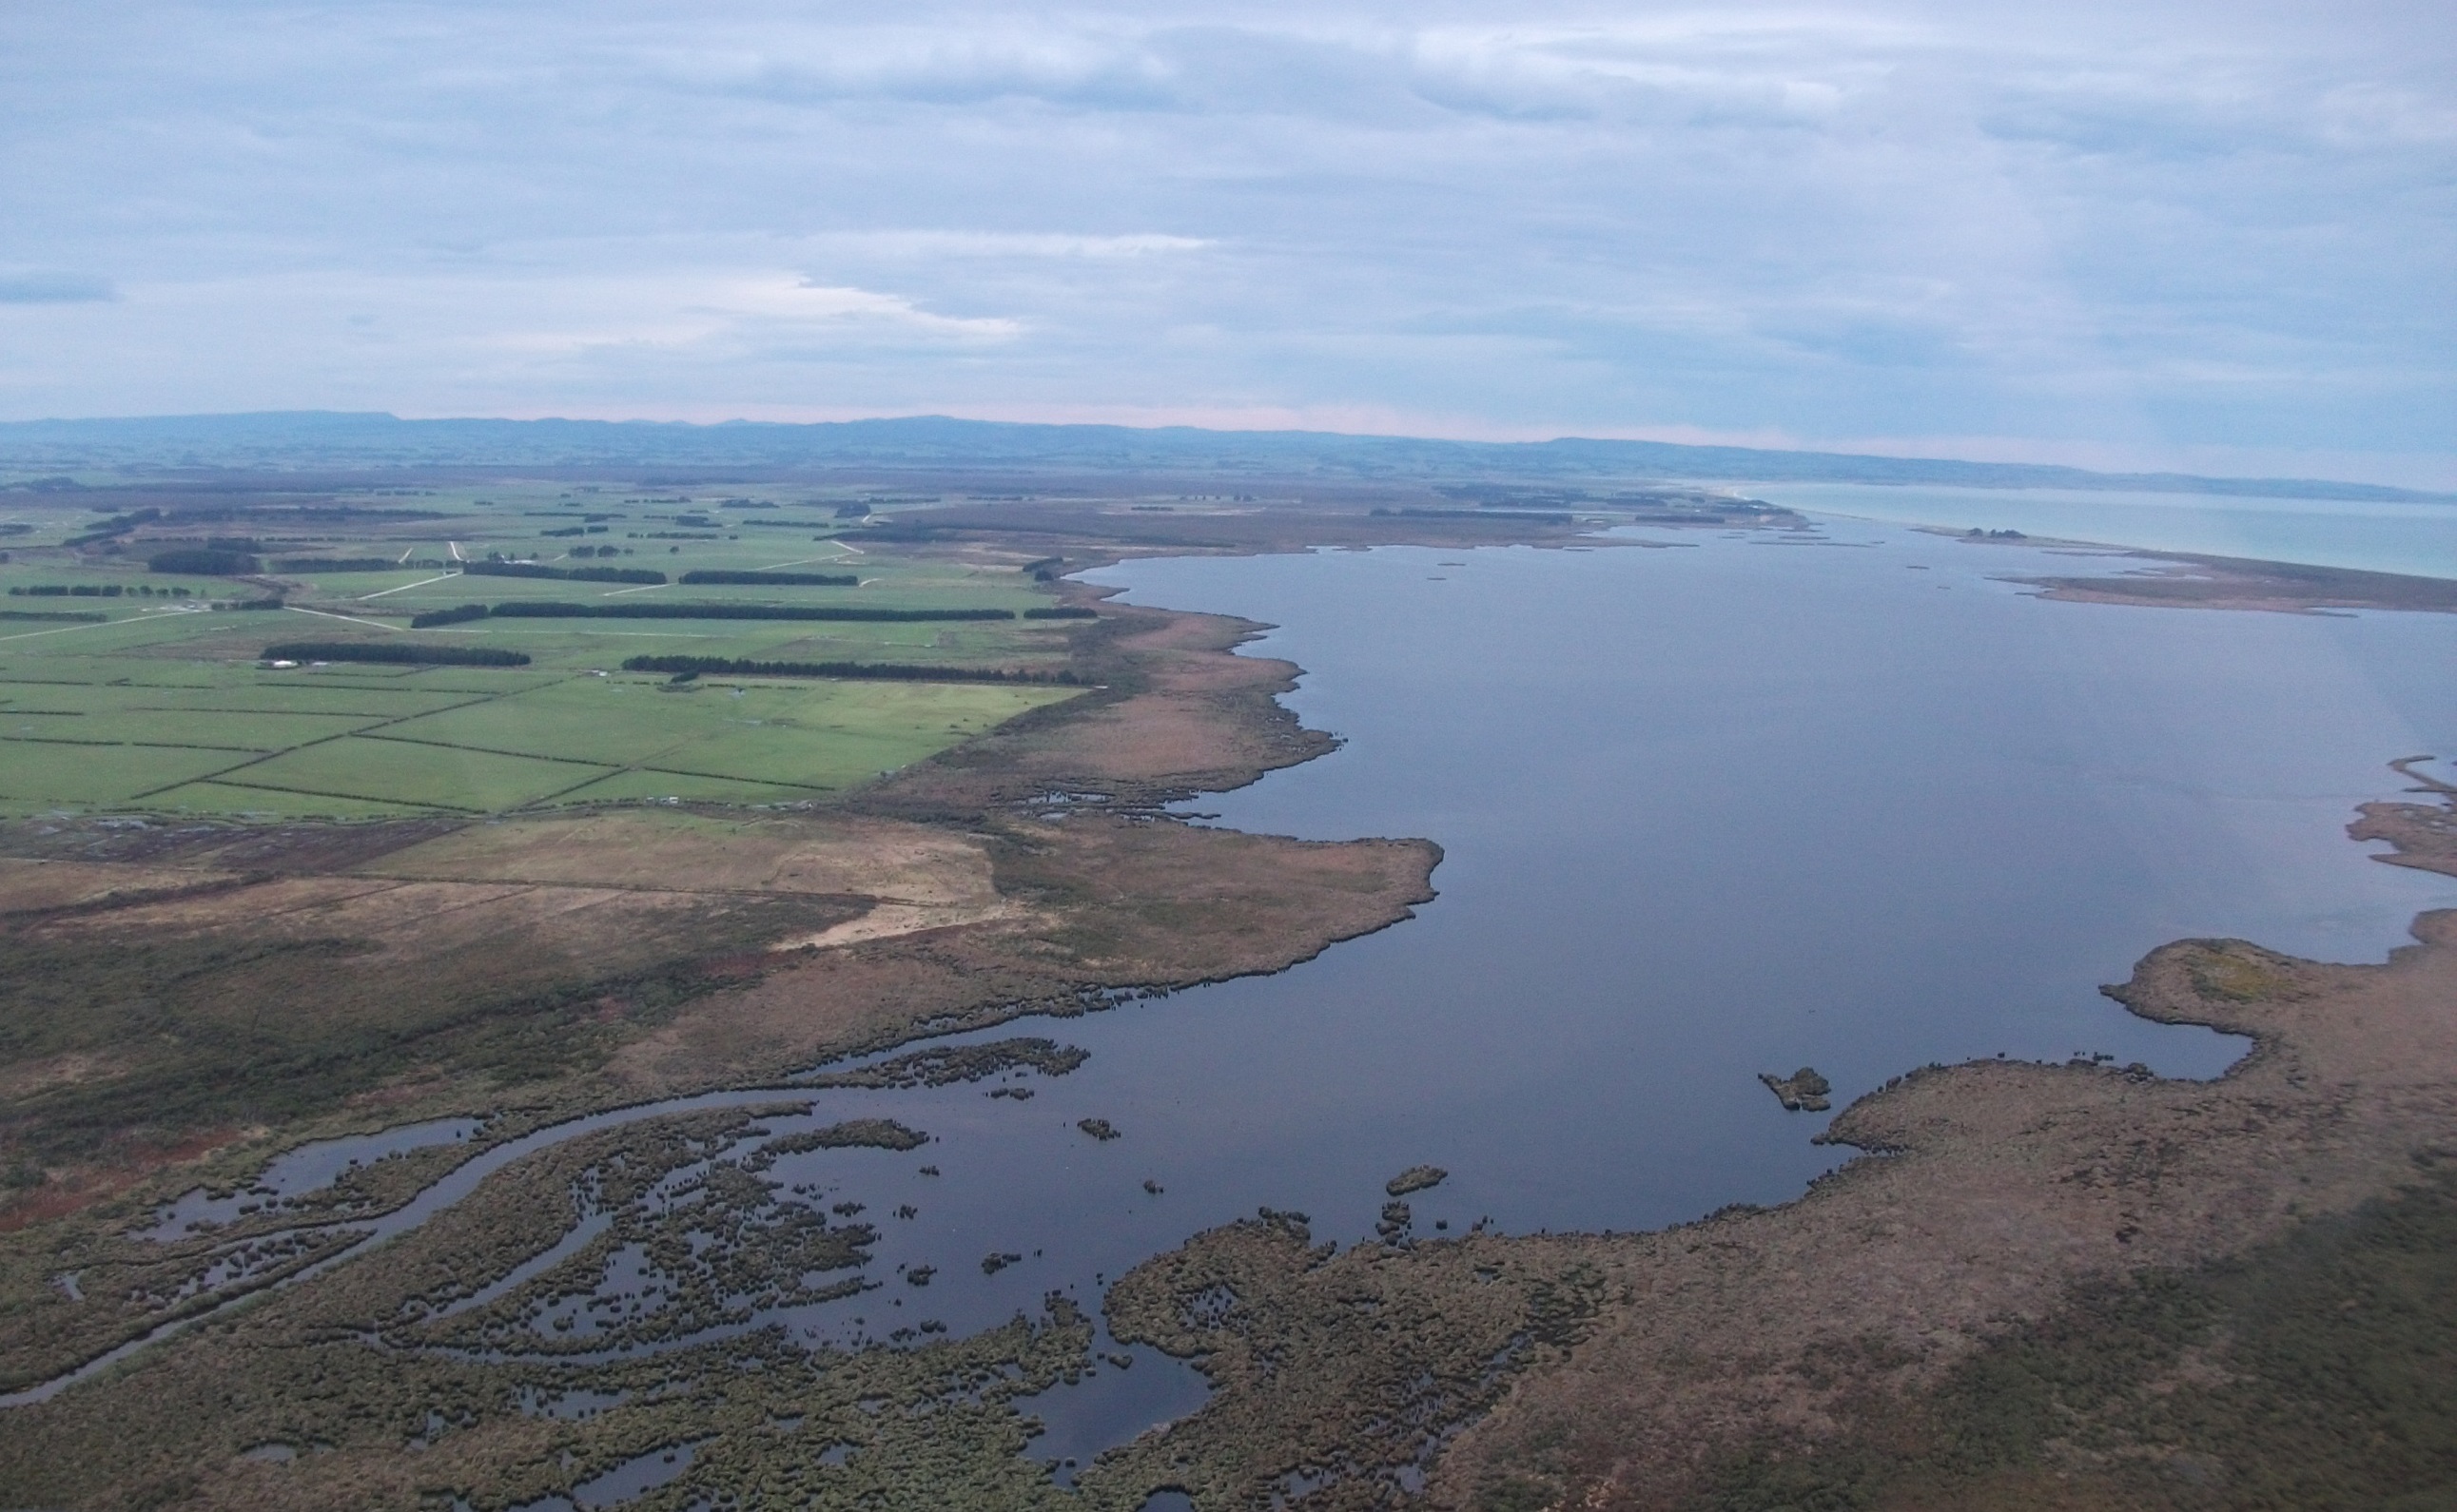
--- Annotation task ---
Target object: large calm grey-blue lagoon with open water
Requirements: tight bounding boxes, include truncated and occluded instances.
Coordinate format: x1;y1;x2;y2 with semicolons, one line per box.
43;520;2457;1461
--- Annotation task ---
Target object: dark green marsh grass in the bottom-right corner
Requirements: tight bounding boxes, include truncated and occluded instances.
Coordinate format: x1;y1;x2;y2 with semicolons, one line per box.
1700;1161;2457;1512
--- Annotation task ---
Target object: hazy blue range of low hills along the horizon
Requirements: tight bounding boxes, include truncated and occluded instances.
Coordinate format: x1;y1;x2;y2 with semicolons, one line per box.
0;410;2457;503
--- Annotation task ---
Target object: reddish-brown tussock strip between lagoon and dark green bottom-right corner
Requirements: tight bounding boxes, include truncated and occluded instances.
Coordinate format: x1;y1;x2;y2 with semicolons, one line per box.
1433;913;2457;1509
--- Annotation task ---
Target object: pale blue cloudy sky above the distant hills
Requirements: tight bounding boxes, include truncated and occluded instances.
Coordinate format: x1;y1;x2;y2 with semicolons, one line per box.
0;0;2457;486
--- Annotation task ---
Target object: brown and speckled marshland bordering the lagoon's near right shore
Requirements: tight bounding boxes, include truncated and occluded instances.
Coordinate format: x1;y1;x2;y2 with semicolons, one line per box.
1103;793;2457;1509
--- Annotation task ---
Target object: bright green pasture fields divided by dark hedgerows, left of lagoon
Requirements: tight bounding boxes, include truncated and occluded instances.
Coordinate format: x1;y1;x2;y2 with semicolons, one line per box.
0;481;1074;818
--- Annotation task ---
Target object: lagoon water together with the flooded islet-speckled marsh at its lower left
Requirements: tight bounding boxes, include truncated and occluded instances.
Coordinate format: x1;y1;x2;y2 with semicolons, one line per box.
17;518;2457;1512
